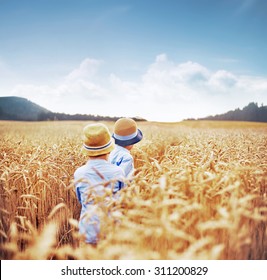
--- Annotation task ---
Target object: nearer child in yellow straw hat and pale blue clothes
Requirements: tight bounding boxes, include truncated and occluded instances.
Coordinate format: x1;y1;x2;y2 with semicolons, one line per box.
74;123;124;244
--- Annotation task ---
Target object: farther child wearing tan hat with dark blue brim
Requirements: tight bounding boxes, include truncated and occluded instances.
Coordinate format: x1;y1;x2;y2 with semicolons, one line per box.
109;118;143;179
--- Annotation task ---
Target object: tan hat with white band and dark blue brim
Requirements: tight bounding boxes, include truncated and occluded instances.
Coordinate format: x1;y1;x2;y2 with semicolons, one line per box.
112;118;143;147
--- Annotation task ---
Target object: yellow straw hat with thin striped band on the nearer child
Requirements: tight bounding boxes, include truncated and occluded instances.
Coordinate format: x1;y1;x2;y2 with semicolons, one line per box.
82;123;114;156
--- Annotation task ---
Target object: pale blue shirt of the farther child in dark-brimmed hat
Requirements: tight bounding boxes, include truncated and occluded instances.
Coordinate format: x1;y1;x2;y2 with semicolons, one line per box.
109;145;134;179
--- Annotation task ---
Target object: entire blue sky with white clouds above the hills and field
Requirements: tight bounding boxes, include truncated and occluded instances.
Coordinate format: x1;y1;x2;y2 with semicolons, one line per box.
0;0;267;122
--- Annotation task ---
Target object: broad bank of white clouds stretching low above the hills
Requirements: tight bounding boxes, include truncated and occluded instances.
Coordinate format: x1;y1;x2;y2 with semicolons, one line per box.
3;54;267;121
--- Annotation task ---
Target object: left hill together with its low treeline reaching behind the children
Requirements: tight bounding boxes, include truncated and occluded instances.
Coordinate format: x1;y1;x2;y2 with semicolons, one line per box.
0;96;146;121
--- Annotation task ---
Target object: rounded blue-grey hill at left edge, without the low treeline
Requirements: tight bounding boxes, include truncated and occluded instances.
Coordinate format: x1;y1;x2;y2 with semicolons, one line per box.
0;96;51;121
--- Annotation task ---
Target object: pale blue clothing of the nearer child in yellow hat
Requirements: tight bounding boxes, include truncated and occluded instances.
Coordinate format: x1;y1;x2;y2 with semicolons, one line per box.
74;159;124;244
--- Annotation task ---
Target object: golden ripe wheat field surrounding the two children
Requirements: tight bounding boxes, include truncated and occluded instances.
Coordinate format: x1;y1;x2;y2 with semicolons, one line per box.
0;121;267;260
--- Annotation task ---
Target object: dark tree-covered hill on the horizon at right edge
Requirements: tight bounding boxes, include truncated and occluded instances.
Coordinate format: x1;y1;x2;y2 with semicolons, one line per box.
199;102;267;122
